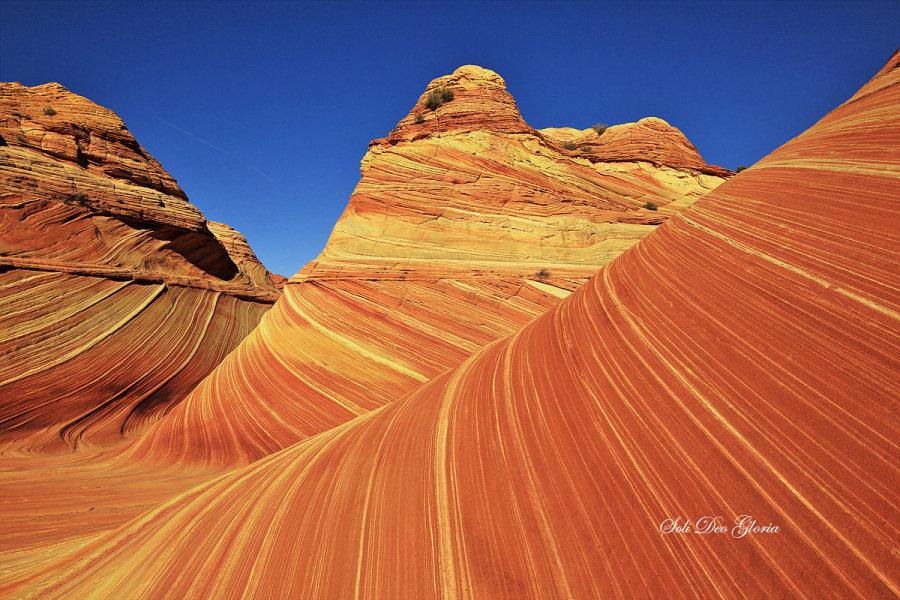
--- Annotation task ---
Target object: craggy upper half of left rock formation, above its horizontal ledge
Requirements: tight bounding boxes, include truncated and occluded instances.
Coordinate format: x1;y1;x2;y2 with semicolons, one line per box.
0;83;277;301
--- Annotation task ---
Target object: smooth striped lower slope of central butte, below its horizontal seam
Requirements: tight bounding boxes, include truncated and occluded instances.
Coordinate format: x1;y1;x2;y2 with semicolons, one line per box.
127;262;587;465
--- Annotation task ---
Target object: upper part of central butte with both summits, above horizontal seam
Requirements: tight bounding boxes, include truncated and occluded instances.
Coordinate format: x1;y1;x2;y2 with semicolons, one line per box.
334;65;731;266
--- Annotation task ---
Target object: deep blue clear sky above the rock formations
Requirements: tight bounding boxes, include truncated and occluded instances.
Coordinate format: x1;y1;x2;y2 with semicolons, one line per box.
0;0;900;275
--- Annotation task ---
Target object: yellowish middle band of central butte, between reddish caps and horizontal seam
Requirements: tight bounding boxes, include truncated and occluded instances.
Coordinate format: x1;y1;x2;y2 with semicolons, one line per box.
320;131;724;268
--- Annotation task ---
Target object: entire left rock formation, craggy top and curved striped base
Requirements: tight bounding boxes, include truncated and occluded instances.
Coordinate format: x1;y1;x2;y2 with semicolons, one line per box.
0;83;278;452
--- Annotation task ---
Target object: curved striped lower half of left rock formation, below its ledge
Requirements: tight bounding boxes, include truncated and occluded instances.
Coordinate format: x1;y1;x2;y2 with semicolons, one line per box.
0;269;270;453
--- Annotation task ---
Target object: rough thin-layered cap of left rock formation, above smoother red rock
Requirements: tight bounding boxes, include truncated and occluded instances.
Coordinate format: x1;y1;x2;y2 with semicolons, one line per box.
0;83;197;231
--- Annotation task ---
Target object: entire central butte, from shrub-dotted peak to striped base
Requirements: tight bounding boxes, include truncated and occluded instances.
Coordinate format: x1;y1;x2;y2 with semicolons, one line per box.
135;66;730;464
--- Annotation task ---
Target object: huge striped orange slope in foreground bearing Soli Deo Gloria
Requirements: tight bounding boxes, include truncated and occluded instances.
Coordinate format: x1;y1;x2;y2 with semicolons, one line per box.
0;55;900;598
